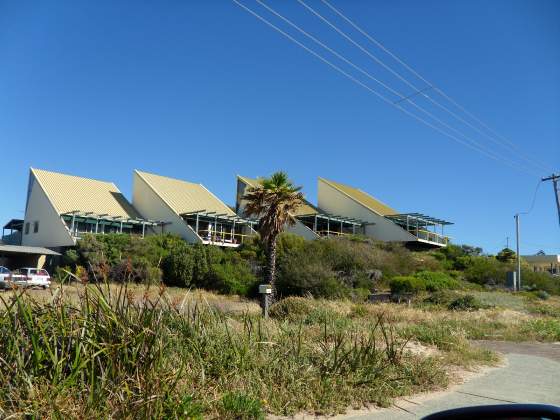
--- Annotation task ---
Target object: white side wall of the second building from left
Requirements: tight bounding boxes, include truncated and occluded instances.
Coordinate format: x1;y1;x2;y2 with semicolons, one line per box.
132;172;202;243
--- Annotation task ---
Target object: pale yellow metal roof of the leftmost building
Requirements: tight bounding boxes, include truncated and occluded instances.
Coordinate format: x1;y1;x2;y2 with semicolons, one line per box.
31;168;140;219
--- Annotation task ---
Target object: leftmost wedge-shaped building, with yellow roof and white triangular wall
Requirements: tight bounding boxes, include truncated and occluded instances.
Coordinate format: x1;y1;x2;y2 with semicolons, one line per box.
19;168;163;249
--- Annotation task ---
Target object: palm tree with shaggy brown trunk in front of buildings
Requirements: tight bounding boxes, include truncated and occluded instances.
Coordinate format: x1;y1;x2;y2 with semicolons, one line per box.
243;172;303;298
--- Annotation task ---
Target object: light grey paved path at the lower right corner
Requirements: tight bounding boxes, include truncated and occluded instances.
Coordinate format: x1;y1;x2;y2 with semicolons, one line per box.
340;342;560;420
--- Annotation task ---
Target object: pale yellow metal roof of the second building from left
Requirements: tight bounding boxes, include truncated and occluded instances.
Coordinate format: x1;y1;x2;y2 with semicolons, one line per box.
136;171;235;216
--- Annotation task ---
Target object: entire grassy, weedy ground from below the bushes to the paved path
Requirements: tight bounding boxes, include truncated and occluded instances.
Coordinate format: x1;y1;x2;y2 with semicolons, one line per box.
4;283;560;419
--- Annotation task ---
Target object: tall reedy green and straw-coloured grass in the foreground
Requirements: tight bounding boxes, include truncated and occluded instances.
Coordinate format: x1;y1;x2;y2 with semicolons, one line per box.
0;285;446;419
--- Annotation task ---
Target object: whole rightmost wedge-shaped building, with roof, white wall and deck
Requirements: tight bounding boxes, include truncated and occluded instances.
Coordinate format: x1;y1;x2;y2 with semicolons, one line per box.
318;178;452;247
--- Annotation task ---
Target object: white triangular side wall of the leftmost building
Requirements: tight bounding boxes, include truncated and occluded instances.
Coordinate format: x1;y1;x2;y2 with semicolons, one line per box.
21;174;75;248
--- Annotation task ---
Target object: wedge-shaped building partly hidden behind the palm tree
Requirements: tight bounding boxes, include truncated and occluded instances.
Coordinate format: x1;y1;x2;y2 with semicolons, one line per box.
236;175;366;239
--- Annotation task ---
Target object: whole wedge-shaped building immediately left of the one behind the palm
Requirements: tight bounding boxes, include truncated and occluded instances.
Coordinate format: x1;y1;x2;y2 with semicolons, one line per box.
132;171;256;247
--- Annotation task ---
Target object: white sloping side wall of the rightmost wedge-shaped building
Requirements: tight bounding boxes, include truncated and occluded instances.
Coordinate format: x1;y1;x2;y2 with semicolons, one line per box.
318;180;418;242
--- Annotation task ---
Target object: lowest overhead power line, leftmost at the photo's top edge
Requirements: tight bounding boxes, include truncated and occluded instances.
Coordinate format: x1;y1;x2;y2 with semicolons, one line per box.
232;0;533;175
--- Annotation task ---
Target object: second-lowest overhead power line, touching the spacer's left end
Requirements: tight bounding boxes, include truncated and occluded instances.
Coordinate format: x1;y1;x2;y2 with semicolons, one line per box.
255;0;540;173
